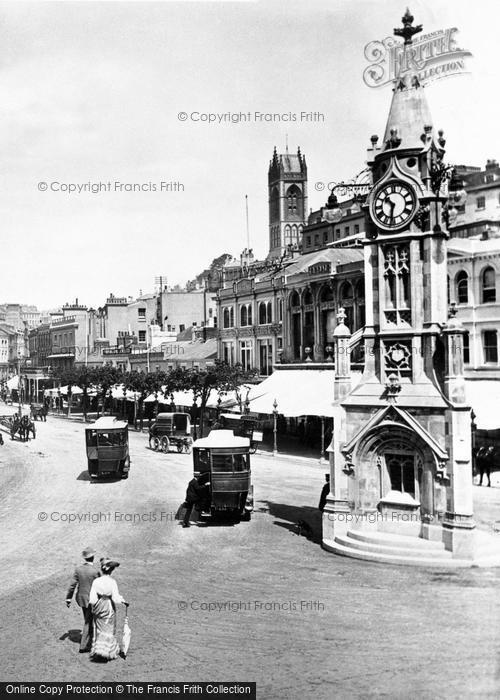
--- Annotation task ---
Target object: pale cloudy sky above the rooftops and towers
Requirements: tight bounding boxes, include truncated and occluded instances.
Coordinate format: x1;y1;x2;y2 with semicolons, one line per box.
0;0;500;309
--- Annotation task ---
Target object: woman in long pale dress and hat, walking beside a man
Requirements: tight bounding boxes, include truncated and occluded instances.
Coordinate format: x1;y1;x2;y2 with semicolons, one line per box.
89;559;127;660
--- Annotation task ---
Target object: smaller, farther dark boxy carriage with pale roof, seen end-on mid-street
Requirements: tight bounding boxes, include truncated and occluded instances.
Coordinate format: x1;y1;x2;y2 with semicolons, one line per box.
85;417;130;479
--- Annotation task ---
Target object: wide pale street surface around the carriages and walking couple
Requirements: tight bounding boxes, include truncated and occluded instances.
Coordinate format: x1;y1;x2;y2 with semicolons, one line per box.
0;417;500;700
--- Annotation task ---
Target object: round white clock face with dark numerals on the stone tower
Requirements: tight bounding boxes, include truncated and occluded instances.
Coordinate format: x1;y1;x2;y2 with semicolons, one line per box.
371;180;417;231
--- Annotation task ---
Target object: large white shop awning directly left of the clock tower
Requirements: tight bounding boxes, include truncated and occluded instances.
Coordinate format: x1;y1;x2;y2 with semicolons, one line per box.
248;368;361;418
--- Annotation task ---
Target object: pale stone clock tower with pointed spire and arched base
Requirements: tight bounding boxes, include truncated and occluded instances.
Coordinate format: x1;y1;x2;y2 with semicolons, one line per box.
323;10;474;562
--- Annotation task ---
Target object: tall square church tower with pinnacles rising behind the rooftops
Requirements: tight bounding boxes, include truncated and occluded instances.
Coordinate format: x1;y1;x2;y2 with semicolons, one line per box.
267;146;307;259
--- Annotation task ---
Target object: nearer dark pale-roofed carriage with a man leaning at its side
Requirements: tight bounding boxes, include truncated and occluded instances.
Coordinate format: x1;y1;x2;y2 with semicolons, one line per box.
193;430;253;520
